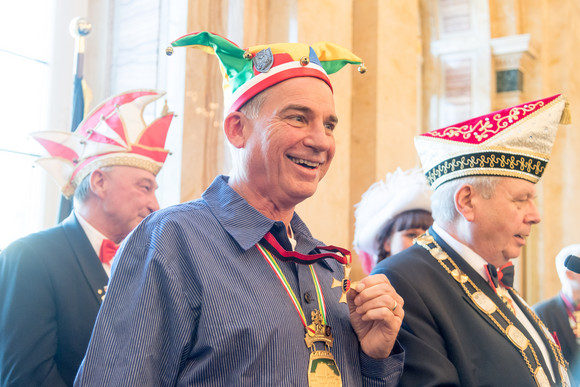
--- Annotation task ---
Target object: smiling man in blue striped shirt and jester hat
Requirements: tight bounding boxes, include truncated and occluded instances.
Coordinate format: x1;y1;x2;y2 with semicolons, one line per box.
75;32;404;387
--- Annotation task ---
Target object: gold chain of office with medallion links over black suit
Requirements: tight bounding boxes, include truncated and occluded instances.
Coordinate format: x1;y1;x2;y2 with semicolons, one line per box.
416;232;570;387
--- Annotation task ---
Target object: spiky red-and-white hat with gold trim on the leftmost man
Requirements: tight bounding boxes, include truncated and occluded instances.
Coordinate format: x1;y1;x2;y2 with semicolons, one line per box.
31;89;173;197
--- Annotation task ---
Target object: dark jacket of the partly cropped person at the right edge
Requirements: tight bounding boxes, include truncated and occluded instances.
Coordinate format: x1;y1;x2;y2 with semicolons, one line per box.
533;295;580;381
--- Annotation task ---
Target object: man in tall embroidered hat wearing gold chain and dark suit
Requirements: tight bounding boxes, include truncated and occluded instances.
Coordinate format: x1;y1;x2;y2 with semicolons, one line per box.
373;95;570;387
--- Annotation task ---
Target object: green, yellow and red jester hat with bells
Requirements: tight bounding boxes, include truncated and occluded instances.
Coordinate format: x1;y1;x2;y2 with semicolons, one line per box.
166;31;366;115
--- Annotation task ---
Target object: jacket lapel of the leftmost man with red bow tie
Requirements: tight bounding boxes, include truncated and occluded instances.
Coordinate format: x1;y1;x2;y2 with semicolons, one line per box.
61;212;109;304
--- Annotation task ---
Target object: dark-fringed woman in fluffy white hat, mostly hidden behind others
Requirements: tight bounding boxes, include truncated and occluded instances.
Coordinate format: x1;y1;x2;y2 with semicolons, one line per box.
353;168;433;274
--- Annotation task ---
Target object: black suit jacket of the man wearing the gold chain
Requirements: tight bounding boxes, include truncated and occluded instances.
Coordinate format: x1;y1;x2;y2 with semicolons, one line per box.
373;229;560;387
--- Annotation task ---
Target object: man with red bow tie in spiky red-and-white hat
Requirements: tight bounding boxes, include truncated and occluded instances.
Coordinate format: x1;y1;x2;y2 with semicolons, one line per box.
0;90;173;386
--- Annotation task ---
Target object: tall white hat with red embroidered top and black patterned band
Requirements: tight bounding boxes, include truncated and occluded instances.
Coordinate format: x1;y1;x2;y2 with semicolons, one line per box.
415;94;570;190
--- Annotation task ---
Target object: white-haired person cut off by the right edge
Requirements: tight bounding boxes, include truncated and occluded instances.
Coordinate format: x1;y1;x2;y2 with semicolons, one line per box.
533;244;580;382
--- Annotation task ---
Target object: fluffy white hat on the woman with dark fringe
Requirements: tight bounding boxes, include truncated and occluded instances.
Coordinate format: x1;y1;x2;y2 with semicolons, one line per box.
353;168;433;273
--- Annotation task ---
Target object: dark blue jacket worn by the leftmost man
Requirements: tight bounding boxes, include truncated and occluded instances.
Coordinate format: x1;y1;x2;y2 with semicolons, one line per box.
0;214;108;387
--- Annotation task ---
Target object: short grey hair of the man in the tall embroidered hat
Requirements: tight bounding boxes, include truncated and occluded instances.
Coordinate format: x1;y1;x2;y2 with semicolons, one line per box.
431;176;501;224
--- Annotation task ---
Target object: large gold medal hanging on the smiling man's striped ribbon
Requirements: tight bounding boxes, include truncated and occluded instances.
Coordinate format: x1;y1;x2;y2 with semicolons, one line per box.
304;310;342;387
